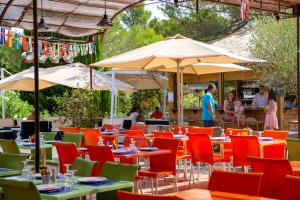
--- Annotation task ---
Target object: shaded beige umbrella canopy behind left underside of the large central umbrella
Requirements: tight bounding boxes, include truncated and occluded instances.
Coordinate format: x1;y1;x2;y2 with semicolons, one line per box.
104;70;168;90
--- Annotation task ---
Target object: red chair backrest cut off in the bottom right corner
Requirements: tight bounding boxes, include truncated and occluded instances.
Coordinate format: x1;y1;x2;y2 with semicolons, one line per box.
279;176;300;200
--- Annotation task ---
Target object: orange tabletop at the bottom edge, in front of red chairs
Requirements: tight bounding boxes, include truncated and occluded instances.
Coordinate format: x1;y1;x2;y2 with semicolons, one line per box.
165;189;274;200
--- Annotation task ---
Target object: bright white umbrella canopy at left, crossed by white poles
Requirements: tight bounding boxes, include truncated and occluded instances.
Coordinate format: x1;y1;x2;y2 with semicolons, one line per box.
40;63;134;92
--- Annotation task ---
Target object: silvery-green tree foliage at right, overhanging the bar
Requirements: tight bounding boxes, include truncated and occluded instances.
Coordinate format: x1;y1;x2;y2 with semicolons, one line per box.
251;18;297;95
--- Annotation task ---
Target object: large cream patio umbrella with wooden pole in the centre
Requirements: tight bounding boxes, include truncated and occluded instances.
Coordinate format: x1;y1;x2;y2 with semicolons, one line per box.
92;35;256;124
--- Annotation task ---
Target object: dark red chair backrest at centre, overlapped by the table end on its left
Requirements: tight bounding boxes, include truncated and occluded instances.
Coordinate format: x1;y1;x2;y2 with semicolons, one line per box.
150;138;179;175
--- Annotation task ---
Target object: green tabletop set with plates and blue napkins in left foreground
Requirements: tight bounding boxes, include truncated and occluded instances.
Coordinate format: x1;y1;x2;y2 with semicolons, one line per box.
2;176;133;200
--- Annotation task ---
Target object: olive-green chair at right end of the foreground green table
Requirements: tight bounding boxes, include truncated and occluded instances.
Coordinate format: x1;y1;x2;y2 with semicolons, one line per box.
97;162;139;200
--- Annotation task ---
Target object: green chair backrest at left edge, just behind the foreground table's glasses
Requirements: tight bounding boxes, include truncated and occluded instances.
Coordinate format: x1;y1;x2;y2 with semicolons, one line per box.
0;153;28;170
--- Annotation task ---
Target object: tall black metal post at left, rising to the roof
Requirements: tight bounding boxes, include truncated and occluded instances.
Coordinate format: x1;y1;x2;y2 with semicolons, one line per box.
32;0;40;173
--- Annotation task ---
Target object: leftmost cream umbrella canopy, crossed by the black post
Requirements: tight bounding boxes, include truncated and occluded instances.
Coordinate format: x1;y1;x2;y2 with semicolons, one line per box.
0;67;56;92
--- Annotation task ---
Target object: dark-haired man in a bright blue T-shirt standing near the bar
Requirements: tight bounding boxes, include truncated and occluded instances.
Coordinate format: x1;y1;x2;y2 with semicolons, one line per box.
202;83;216;127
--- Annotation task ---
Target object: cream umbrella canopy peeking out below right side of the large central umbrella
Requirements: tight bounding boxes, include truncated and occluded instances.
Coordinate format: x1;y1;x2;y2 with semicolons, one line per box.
159;63;250;75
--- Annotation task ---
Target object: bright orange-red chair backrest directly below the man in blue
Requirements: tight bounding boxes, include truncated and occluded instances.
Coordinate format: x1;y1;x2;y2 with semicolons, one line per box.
188;133;213;164
